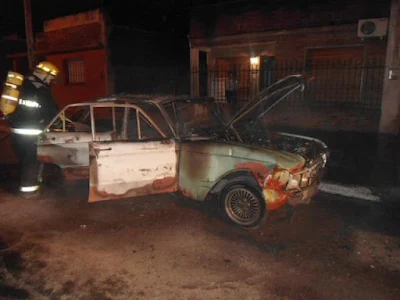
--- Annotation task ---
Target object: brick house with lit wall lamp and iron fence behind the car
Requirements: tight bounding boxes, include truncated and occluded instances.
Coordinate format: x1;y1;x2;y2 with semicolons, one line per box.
190;0;390;130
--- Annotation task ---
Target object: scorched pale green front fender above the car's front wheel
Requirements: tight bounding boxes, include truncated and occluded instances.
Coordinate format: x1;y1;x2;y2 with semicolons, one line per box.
179;141;304;201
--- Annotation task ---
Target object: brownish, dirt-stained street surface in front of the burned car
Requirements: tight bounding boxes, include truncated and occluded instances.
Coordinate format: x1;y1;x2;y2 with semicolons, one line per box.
0;183;400;300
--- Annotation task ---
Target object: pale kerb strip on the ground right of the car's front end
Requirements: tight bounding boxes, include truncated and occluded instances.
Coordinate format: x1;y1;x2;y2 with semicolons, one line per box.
319;182;381;202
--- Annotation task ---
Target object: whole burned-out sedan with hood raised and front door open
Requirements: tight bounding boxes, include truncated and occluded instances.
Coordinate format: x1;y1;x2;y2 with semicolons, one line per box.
38;75;328;228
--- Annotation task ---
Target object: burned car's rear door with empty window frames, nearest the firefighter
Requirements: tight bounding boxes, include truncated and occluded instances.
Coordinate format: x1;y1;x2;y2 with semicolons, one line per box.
37;103;118;179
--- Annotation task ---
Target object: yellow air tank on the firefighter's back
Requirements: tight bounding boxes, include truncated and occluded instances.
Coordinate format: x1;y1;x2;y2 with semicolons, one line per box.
0;72;24;116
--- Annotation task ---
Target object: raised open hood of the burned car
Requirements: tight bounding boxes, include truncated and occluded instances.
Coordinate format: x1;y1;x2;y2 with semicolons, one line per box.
226;75;304;128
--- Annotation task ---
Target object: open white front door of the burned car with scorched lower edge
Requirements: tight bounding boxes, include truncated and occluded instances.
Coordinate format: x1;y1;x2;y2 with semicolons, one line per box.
89;108;178;202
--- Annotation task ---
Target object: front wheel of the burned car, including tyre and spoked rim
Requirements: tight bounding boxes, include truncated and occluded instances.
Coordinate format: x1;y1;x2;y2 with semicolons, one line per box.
219;183;266;229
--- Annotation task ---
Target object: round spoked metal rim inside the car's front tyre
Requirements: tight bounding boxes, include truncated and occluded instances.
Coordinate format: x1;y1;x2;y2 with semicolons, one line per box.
225;188;262;225
